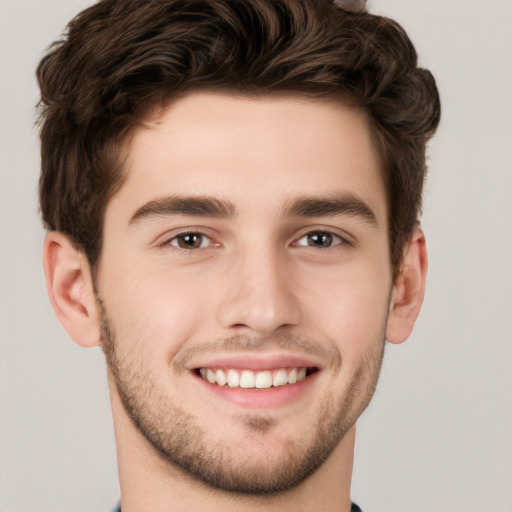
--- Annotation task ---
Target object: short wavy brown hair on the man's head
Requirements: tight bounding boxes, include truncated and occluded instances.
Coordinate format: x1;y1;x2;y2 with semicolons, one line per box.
37;0;440;269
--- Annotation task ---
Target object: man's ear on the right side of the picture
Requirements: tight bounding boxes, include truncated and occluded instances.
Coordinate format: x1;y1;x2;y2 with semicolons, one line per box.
386;229;428;343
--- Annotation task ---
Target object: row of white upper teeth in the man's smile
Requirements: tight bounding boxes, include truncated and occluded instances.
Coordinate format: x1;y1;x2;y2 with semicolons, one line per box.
199;368;306;389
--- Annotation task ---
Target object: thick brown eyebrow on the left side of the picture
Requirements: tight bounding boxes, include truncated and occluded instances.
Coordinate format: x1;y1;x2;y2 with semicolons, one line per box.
129;196;235;224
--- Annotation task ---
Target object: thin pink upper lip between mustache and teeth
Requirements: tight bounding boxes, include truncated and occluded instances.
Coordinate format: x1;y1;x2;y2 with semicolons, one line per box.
187;353;321;370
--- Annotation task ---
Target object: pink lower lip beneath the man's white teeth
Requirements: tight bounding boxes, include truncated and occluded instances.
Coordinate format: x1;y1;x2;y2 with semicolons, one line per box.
196;372;319;409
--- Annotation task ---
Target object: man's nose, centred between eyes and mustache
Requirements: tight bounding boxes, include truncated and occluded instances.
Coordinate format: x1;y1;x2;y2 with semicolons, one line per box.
218;245;301;336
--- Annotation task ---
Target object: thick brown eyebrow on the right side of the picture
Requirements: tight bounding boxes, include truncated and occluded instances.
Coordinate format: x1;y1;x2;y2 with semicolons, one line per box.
284;194;379;226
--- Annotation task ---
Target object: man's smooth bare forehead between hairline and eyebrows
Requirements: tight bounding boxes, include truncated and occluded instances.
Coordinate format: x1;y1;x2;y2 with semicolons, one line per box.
107;92;385;220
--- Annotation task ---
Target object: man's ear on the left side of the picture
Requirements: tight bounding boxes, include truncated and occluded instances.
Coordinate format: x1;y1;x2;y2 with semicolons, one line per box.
43;231;101;347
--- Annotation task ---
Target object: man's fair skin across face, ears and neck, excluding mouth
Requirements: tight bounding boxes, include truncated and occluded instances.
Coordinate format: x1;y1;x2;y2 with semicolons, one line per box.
44;92;427;512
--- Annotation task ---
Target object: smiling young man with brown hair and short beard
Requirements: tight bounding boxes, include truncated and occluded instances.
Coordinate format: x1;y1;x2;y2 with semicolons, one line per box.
38;0;440;512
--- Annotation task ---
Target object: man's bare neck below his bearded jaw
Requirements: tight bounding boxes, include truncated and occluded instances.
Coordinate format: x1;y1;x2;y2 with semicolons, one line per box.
111;378;355;512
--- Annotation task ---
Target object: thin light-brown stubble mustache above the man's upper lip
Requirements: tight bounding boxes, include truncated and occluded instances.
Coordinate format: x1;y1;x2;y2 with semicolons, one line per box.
174;334;341;369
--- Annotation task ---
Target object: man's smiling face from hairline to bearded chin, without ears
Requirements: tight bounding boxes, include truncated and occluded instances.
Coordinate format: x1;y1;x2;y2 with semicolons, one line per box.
96;93;392;493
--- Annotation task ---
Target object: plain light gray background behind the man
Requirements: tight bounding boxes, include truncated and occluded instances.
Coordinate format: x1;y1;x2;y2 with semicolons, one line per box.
0;0;512;512
